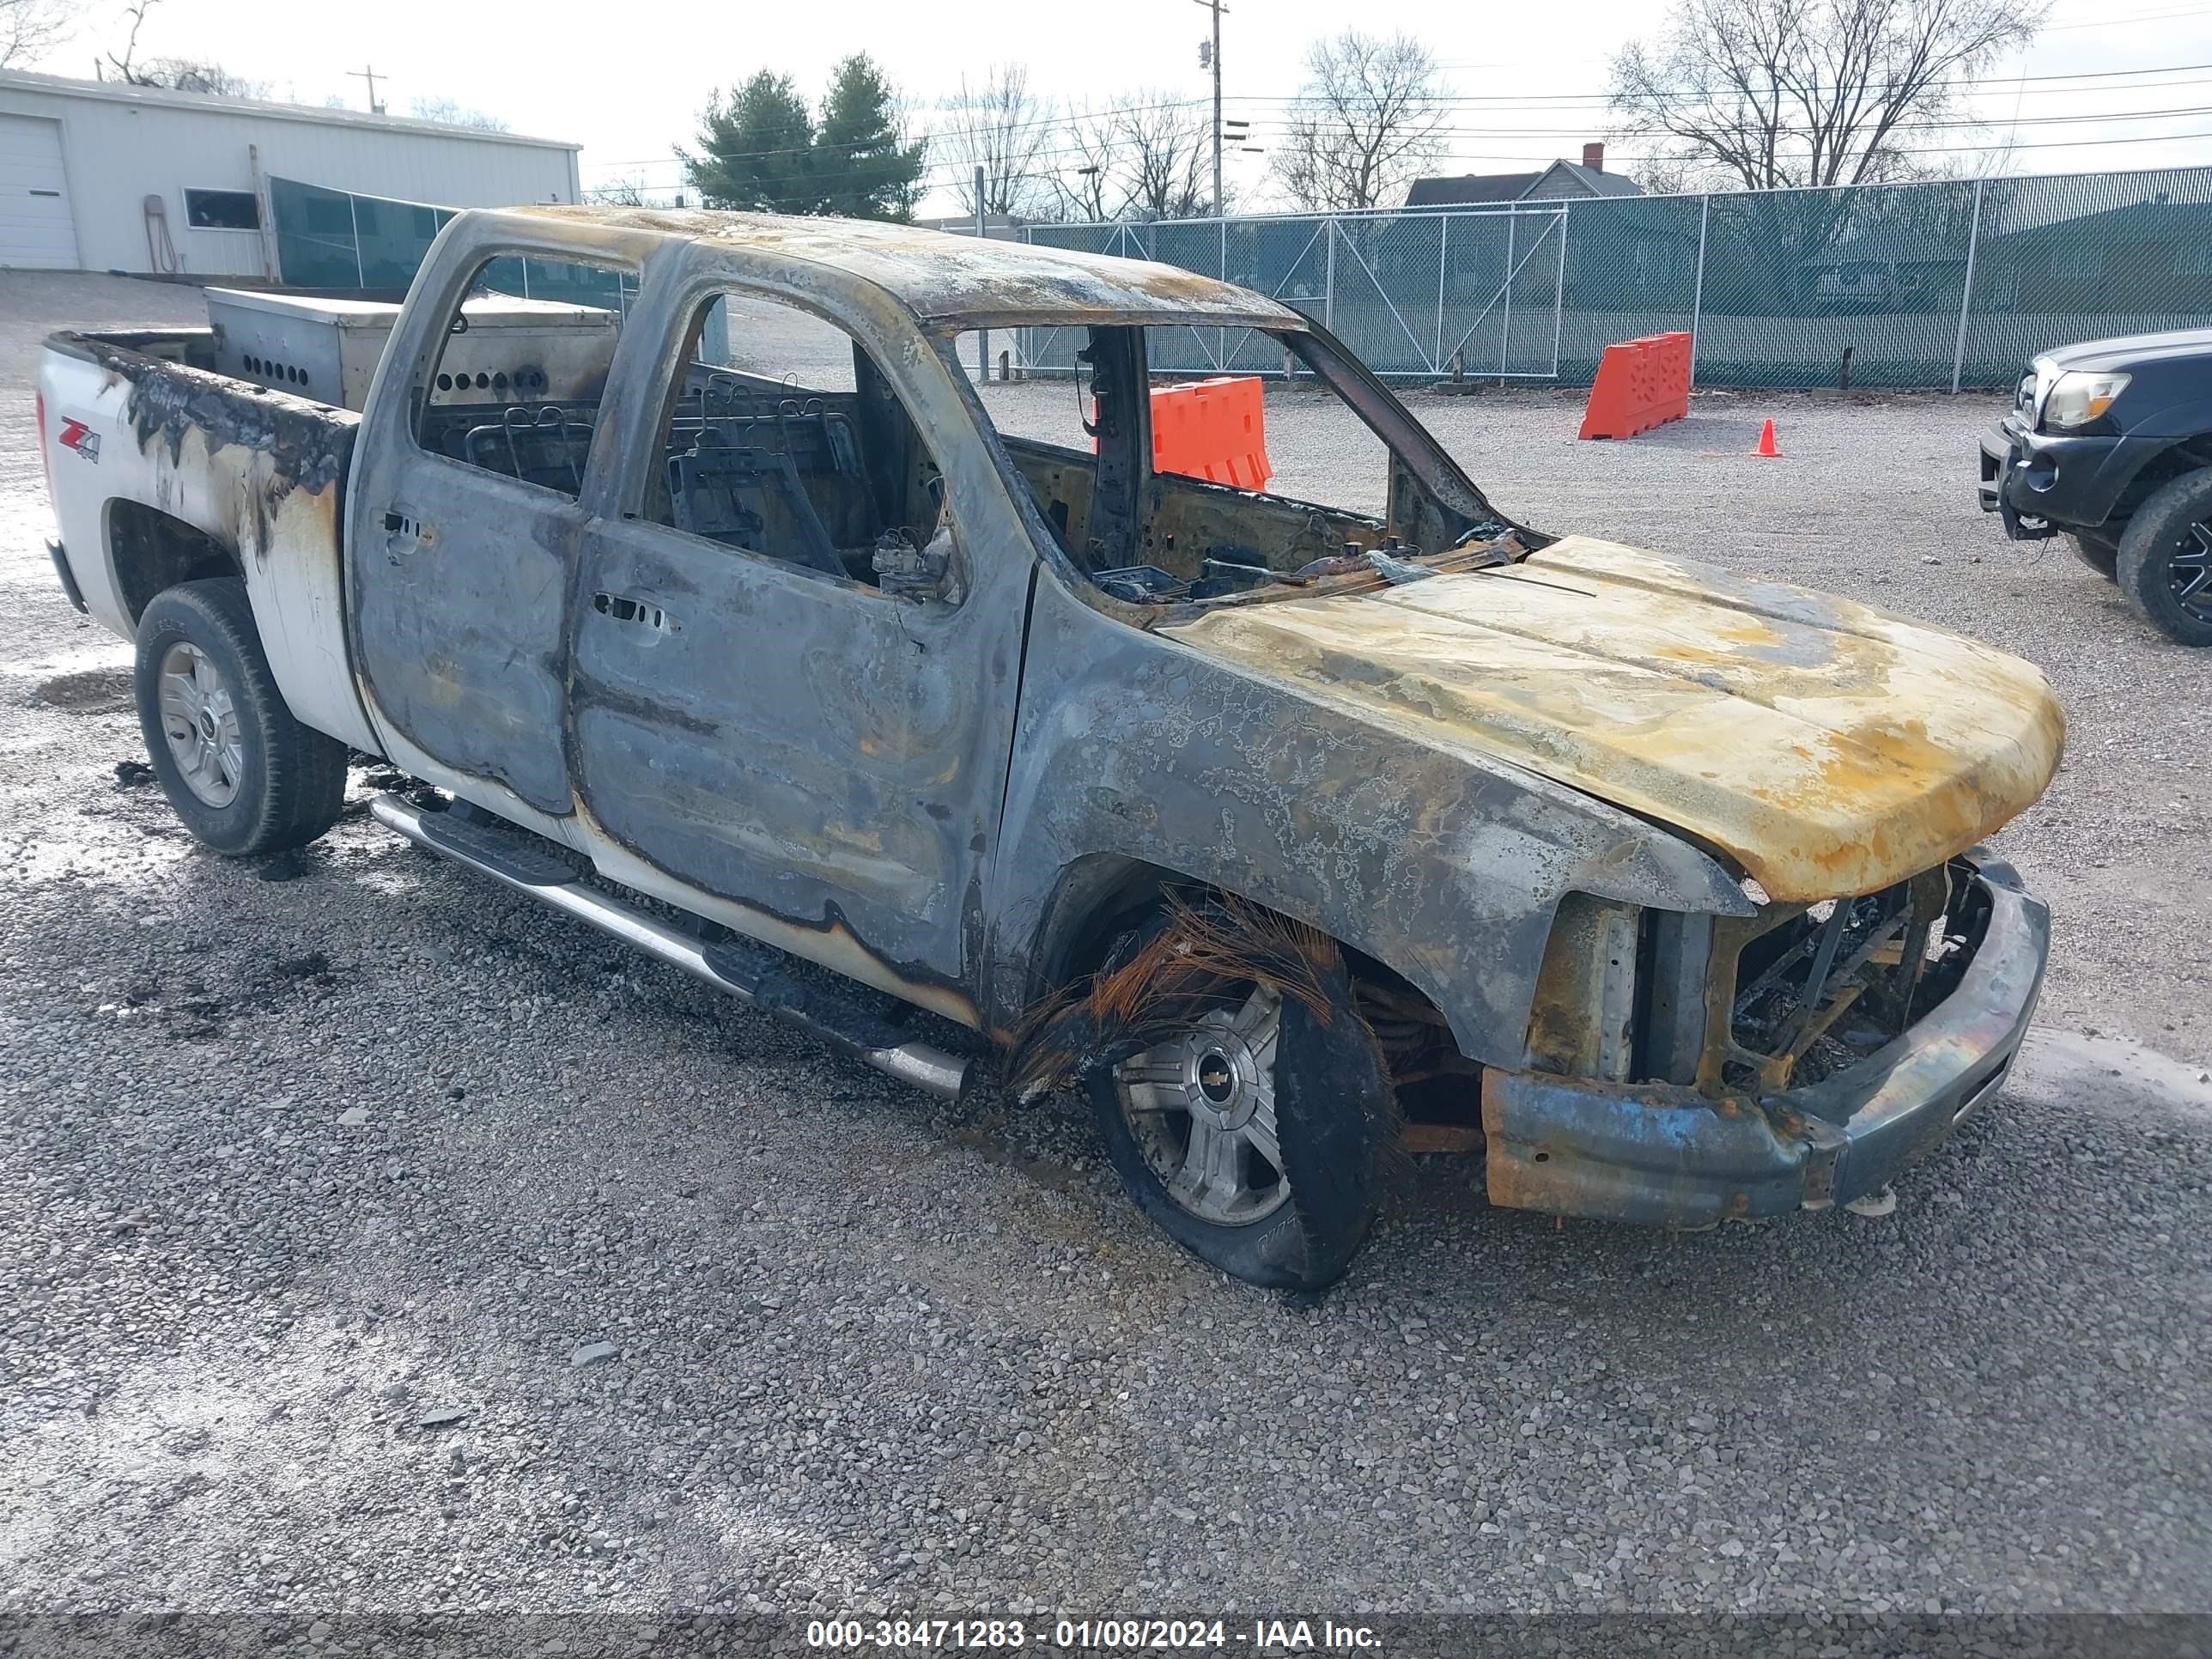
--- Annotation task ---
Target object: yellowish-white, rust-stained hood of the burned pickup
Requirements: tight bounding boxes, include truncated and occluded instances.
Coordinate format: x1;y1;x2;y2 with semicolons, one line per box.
1161;535;2066;900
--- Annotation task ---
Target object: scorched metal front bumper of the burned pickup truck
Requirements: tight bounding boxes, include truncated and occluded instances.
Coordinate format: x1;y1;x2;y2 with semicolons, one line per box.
1482;865;2051;1228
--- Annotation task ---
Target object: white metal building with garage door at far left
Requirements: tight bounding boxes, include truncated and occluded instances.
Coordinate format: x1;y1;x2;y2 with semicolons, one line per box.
0;69;577;276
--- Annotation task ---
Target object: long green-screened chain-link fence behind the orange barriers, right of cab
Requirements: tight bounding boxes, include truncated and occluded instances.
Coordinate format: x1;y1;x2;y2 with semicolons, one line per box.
1022;168;2212;387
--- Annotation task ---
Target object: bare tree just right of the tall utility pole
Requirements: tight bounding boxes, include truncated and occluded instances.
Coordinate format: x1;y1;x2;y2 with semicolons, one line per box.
1267;28;1449;210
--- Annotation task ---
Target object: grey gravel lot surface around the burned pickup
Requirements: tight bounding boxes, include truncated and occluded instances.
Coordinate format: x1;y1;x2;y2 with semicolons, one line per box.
0;272;2212;1617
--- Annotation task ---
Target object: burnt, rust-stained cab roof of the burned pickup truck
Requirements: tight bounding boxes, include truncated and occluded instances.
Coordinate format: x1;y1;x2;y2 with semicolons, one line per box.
500;206;1305;330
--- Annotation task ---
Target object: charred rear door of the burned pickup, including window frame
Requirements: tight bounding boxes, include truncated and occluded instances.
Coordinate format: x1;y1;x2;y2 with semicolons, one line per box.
345;235;650;818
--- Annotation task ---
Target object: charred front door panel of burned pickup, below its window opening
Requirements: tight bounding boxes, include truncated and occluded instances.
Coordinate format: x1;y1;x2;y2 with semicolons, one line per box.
573;522;1020;1008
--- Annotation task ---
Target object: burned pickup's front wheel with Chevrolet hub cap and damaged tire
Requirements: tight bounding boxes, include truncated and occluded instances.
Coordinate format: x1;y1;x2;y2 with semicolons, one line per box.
1088;915;1398;1290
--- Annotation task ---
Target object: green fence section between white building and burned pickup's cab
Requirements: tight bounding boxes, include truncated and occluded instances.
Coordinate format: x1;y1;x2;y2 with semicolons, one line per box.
270;177;630;310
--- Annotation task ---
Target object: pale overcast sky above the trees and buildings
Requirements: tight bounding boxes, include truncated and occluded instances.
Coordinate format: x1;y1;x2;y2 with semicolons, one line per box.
35;0;2212;212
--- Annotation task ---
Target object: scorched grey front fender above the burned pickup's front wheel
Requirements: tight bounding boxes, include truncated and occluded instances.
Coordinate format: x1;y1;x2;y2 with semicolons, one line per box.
988;577;1750;1064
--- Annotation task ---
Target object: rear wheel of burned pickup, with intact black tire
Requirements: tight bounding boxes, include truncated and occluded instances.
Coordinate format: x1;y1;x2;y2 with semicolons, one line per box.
135;577;345;858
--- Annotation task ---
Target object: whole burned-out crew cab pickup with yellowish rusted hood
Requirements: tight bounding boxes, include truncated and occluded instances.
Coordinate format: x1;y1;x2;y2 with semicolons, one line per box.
40;208;2062;1287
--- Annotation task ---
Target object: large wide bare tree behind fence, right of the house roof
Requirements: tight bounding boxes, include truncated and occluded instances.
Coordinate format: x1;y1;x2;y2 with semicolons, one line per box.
1613;0;2044;191
